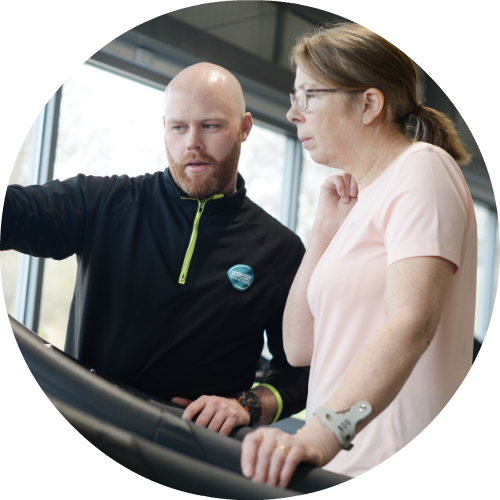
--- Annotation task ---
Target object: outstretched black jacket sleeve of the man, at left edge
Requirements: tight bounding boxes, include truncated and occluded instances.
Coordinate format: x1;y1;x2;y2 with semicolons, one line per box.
0;174;117;260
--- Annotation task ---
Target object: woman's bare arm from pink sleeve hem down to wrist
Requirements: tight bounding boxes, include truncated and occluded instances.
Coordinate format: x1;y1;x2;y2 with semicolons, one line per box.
301;257;455;463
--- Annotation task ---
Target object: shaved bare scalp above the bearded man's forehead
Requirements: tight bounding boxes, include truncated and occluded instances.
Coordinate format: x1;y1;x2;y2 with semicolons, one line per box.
163;62;246;119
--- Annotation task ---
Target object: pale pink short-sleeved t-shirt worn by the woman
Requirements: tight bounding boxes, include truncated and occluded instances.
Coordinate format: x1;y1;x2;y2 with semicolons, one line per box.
306;142;477;477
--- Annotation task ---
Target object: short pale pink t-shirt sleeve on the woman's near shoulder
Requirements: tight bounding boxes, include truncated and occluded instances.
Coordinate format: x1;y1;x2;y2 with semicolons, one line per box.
378;149;468;273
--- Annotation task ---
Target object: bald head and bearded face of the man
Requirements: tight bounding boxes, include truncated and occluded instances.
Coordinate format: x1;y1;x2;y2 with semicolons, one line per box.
163;63;252;199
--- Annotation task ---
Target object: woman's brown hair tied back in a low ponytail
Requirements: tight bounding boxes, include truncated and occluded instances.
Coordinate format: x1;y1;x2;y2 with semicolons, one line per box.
291;23;470;163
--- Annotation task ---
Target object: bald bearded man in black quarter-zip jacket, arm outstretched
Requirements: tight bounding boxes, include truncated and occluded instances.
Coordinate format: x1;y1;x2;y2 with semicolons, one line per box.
0;63;308;435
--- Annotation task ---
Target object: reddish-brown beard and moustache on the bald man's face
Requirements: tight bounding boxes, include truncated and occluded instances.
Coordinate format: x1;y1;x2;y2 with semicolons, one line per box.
165;128;241;200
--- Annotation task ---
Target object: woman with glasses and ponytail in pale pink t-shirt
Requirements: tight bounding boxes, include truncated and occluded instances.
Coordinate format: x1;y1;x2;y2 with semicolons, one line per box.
241;24;477;487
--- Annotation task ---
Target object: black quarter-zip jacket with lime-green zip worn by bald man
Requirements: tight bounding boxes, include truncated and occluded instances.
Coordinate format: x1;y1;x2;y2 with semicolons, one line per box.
0;169;309;418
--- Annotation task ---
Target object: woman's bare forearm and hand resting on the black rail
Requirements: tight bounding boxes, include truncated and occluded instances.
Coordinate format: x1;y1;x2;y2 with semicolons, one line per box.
241;314;438;487
